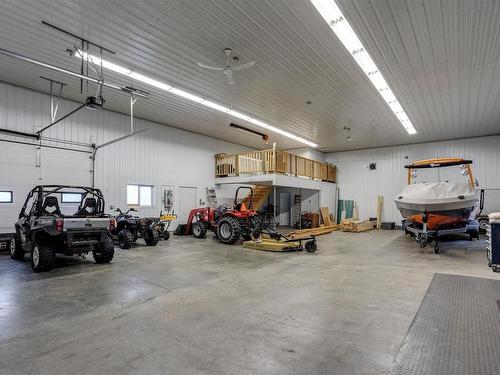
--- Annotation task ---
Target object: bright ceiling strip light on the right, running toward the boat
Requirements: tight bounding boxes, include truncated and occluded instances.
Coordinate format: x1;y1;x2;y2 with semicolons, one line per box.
311;0;417;135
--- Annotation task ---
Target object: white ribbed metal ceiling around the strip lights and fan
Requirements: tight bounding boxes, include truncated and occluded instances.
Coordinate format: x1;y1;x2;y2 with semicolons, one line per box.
0;0;500;151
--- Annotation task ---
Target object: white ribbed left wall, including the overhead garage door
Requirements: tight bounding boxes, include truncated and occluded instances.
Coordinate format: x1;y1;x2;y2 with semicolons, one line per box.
0;82;248;228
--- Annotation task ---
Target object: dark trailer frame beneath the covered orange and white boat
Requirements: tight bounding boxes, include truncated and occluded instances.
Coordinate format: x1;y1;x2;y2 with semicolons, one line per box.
403;219;479;254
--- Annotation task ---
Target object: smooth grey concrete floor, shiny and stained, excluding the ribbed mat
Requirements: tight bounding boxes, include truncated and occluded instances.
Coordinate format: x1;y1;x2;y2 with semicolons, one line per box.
0;231;500;375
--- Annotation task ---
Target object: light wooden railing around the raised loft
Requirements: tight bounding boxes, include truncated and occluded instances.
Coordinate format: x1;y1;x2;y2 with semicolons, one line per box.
215;149;337;182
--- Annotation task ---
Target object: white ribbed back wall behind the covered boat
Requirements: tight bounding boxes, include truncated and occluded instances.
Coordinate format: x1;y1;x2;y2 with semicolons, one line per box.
326;136;500;223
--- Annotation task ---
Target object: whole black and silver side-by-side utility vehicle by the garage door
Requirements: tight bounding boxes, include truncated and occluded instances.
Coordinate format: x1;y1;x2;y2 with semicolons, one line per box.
10;185;114;272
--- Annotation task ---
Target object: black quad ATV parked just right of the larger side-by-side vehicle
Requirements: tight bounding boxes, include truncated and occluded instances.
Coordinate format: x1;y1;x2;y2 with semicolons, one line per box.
111;208;159;249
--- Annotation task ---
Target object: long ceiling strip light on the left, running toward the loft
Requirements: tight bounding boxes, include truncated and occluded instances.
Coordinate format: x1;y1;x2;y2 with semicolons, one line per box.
74;50;318;147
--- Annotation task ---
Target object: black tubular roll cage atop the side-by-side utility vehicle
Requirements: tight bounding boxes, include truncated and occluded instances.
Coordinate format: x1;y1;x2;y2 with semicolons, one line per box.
19;185;105;219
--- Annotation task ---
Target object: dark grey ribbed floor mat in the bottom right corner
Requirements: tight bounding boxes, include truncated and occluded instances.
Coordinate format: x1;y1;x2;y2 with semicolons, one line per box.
391;274;500;375
